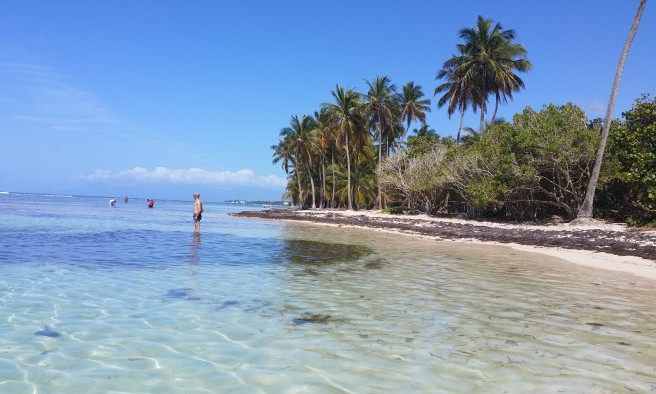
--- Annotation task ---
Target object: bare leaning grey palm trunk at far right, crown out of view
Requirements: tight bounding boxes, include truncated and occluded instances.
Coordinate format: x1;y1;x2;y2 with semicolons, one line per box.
577;0;647;218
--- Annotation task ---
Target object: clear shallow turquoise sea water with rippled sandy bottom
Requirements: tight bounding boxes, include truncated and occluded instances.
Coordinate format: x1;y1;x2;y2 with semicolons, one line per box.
0;193;656;393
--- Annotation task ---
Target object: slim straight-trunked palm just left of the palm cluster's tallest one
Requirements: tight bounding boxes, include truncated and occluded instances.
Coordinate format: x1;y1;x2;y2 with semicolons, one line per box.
322;85;365;210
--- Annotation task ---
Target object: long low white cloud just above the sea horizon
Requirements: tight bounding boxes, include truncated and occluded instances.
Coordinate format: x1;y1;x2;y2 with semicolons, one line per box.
82;167;287;187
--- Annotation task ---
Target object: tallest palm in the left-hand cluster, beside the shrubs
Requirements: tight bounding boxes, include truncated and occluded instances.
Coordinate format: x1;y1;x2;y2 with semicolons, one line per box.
363;77;396;209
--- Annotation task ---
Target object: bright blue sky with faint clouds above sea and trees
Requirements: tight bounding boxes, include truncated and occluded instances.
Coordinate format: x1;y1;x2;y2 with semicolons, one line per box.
0;0;656;202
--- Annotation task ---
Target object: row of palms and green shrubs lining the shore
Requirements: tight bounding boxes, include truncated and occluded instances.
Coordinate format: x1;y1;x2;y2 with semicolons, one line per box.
271;10;656;226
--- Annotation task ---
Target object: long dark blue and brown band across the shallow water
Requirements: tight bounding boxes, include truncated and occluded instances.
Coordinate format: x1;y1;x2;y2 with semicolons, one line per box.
0;223;374;274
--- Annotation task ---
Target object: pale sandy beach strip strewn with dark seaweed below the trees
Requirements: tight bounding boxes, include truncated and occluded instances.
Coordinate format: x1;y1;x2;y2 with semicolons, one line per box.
232;209;656;280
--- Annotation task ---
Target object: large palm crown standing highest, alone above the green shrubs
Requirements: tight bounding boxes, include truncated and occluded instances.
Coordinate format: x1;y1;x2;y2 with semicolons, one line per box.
436;16;531;131
